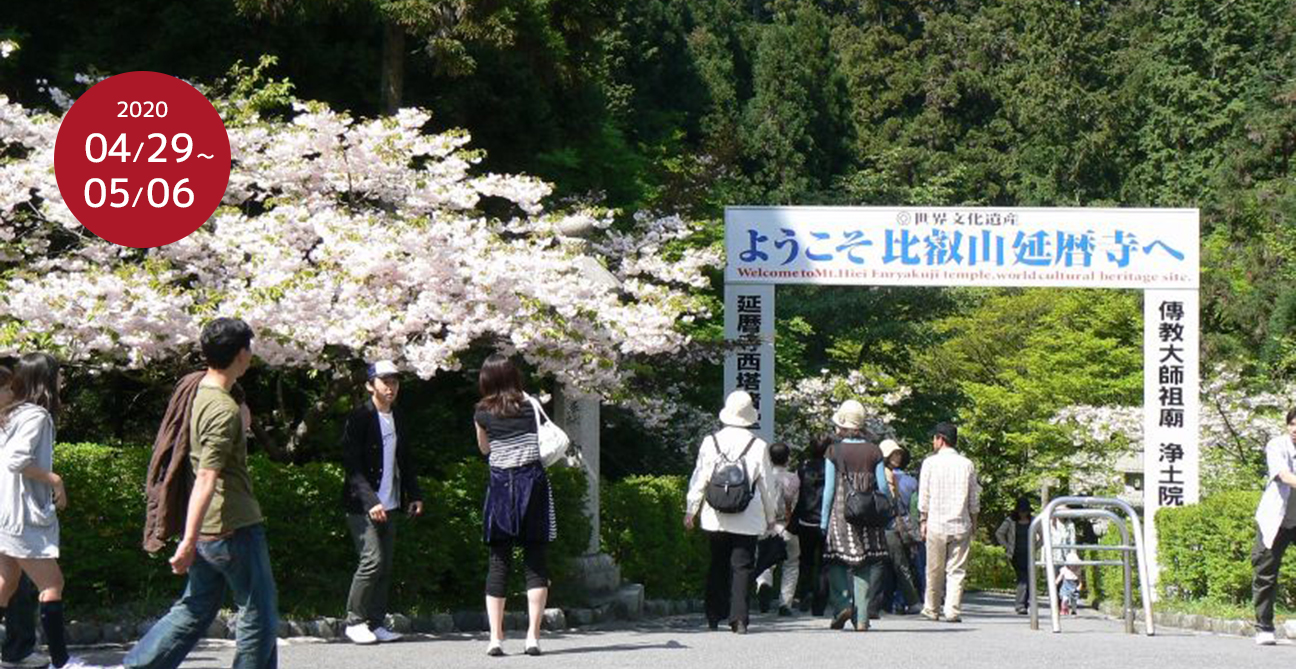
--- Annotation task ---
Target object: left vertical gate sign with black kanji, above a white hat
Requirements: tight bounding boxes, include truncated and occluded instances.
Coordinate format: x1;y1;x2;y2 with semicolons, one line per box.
724;284;774;442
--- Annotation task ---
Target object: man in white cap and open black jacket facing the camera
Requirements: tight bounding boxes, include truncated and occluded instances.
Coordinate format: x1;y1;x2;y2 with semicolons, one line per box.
342;360;422;644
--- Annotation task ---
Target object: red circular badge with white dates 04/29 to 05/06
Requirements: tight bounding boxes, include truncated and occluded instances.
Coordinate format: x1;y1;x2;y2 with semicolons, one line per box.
54;71;229;249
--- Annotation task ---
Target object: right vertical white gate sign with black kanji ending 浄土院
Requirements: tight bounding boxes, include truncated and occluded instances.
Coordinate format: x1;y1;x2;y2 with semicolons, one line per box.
1143;290;1200;591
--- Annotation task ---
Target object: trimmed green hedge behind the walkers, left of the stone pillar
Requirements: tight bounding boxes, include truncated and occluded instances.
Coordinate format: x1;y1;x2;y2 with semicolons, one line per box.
54;445;590;615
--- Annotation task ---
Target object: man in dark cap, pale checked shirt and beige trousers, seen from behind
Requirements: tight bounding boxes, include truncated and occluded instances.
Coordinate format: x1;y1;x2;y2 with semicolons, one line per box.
918;423;981;622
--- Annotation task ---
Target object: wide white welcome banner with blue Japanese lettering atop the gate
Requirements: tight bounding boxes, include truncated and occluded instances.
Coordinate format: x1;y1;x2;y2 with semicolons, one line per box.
724;207;1200;289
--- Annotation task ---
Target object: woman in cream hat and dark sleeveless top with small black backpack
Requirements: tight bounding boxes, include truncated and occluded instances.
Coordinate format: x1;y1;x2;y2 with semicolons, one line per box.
819;399;886;631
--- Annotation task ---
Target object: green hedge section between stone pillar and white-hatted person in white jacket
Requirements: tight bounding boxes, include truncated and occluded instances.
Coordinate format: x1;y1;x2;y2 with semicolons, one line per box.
600;476;710;598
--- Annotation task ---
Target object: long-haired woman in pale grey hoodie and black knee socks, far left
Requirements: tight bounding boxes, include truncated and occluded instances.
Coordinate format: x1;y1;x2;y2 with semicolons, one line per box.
0;353;82;668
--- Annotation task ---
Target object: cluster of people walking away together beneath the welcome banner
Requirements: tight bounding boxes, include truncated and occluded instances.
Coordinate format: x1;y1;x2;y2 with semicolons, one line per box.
684;390;980;634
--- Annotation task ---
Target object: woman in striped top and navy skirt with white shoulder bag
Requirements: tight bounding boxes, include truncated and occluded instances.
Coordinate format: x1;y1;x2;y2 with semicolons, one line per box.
473;354;557;657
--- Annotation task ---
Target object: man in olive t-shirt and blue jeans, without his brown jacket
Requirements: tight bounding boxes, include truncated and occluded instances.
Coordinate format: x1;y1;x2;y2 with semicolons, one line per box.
123;318;279;669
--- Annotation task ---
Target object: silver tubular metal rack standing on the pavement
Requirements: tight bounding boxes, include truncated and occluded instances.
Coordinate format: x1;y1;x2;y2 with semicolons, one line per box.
1026;497;1156;637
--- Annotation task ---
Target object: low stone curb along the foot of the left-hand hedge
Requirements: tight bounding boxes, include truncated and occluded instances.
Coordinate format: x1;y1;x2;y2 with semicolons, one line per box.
30;586;702;646
